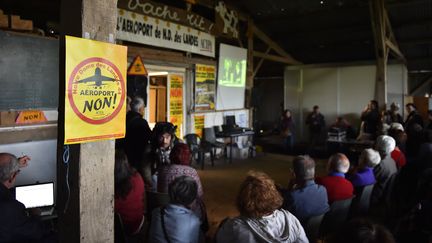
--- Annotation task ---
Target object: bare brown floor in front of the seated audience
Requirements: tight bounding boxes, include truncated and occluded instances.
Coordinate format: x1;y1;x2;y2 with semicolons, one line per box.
197;153;326;238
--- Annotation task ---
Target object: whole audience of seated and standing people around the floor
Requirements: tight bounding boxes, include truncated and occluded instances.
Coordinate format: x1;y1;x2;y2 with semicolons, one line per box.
0;98;432;243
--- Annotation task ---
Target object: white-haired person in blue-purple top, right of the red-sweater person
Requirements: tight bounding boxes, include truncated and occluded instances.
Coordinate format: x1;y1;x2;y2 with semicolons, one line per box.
347;148;381;188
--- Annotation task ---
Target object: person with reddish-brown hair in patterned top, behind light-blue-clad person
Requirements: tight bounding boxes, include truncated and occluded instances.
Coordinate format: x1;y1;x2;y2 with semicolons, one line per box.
157;143;206;224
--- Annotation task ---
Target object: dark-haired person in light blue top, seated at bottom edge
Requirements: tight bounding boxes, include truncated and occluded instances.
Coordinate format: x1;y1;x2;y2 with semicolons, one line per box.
149;176;203;243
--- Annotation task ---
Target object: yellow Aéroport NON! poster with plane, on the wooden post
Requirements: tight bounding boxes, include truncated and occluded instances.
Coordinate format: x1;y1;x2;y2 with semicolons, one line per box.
64;36;127;144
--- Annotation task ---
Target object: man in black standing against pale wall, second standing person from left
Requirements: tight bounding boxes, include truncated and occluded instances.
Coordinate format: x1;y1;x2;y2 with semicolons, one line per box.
306;105;325;150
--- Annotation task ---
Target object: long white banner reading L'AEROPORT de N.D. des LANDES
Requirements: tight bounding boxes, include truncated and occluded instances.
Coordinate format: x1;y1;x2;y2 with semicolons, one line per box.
117;9;215;57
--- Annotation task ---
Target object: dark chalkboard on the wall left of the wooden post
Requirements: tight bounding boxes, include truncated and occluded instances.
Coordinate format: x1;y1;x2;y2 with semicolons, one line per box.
0;31;59;111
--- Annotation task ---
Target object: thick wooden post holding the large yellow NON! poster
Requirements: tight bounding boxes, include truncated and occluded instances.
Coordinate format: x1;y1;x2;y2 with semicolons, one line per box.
57;0;117;242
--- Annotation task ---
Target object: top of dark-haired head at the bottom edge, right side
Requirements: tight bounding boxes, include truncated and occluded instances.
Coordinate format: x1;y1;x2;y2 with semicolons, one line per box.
325;219;396;243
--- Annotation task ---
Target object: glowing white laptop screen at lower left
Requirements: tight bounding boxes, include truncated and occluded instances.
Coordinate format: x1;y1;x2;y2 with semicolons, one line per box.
15;182;54;208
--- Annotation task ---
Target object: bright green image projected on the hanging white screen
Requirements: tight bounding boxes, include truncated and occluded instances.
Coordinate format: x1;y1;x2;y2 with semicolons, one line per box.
219;58;246;87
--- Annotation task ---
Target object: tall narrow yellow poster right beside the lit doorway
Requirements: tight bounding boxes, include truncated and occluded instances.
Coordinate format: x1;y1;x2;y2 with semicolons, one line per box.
169;74;183;138
